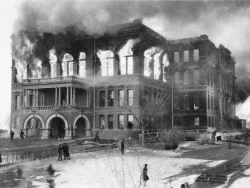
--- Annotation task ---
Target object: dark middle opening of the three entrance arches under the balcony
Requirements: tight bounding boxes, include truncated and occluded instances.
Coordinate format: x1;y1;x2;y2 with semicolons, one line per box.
49;117;65;138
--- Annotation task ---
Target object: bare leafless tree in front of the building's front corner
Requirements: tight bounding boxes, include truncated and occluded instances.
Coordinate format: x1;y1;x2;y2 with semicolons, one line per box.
122;92;171;146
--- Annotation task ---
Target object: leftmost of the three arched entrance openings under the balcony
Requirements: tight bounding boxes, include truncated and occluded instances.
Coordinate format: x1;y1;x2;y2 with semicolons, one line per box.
26;117;42;138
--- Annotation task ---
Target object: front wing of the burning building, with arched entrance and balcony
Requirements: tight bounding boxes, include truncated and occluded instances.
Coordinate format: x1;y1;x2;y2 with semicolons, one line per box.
11;20;169;138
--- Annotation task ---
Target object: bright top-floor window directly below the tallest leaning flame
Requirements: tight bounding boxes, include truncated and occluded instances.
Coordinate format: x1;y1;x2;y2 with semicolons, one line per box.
119;56;133;75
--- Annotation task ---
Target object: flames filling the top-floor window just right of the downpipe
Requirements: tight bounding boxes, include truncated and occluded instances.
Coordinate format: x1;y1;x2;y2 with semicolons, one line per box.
97;50;114;76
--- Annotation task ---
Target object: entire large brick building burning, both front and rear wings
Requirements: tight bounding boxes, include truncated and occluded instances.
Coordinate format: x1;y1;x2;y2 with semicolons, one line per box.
10;20;242;139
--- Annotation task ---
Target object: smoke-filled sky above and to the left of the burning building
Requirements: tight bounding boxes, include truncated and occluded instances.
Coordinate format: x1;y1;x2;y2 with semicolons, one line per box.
0;0;250;129
